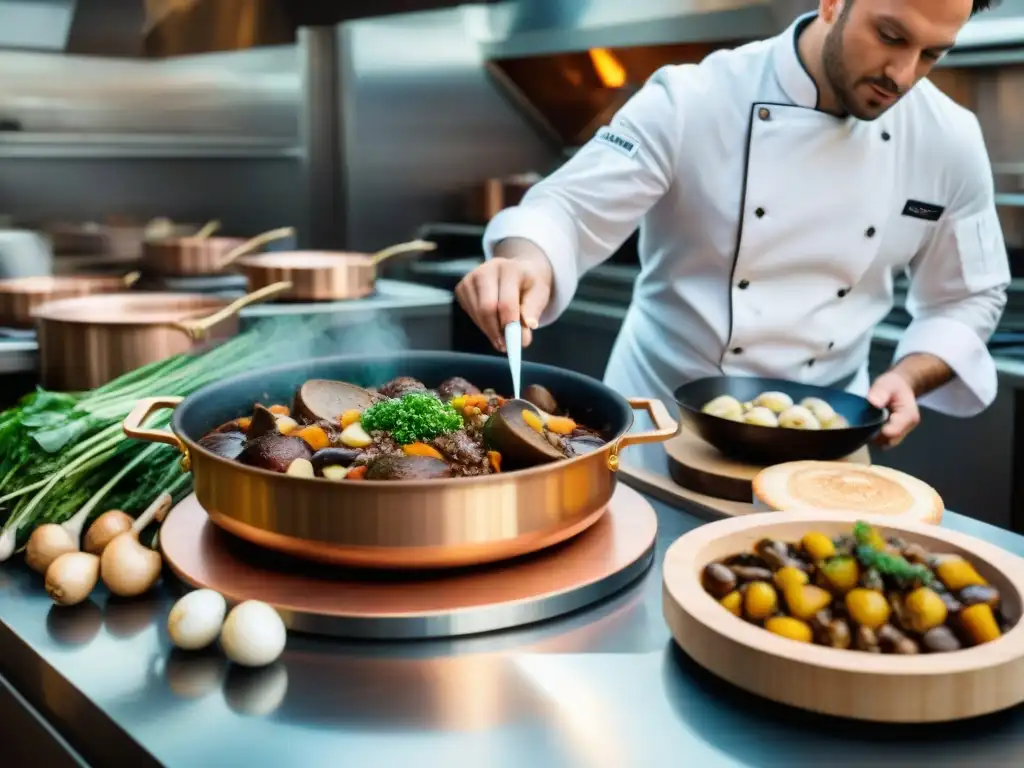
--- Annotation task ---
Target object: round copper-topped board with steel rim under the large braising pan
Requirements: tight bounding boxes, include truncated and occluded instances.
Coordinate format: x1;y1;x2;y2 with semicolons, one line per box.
160;483;657;639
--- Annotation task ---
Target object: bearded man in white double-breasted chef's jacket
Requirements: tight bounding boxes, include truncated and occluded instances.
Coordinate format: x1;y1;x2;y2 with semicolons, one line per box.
456;0;1010;469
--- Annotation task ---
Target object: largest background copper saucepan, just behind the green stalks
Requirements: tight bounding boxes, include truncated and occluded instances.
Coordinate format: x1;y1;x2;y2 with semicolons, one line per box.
33;283;291;392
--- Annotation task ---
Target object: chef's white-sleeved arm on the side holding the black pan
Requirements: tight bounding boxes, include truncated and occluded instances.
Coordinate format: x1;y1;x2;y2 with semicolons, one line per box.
894;122;1010;417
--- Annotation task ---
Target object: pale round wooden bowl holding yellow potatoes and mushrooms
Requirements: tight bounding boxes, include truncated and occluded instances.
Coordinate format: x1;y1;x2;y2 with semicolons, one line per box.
663;512;1024;723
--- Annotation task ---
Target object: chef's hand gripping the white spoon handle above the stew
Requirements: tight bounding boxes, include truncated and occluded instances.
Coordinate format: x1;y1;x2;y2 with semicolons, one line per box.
455;238;553;352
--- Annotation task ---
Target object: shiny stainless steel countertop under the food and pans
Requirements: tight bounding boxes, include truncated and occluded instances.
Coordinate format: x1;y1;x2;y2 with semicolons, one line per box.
0;462;1024;768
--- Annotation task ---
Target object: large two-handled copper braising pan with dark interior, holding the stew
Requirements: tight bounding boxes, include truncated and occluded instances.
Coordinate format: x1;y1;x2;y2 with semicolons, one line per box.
124;352;678;568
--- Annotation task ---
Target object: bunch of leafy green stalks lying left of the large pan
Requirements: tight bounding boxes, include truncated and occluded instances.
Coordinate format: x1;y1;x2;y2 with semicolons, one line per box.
0;321;335;561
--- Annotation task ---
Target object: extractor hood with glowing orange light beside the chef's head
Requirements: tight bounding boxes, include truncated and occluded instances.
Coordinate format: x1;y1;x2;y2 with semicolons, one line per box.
479;0;817;150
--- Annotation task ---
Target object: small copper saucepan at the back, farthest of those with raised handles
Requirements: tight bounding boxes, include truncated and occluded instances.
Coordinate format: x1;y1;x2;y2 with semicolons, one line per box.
141;222;295;276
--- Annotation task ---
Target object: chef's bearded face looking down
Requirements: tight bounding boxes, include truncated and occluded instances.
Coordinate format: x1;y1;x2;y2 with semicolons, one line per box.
819;0;972;120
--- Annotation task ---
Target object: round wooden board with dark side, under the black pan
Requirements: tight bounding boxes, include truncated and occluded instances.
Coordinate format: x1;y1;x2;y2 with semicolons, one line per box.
665;426;871;504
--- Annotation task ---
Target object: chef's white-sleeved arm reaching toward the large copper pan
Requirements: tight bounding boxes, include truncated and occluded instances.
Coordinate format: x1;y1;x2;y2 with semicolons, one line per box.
483;68;689;325
